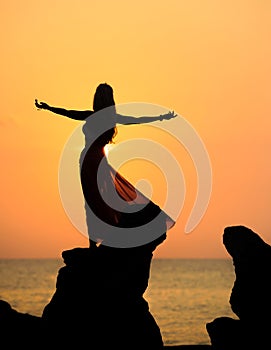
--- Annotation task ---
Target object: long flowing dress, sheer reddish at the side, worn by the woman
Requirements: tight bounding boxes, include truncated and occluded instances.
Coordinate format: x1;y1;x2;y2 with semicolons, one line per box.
80;111;174;247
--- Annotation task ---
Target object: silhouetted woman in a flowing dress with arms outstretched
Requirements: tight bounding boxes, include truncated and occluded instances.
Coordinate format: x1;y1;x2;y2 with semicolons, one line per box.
35;83;176;247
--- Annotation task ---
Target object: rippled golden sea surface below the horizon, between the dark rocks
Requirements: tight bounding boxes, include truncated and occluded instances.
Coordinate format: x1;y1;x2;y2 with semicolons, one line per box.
0;258;236;345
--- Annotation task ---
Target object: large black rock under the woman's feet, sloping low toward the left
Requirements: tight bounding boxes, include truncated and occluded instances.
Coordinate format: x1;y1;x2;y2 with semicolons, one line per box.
0;235;166;350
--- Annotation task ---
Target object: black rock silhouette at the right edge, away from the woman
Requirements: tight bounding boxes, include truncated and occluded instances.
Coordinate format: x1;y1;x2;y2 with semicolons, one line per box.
206;226;271;350
